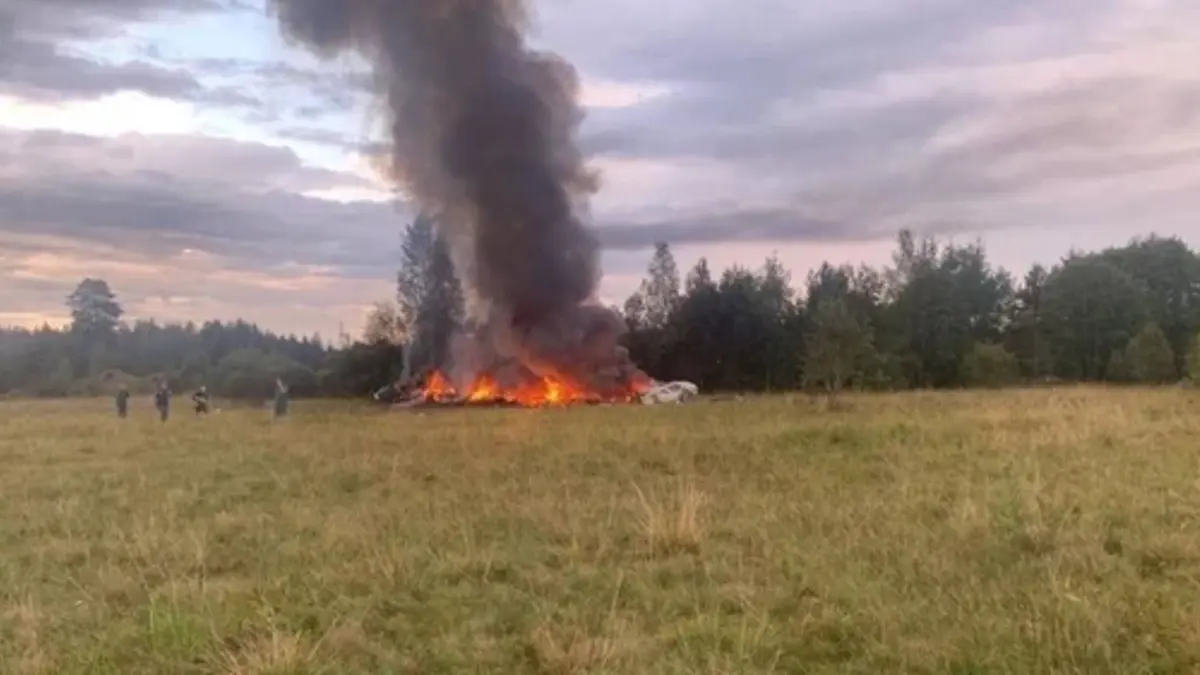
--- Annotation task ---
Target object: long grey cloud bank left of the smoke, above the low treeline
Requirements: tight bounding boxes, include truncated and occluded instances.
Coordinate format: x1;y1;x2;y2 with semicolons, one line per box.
0;132;403;276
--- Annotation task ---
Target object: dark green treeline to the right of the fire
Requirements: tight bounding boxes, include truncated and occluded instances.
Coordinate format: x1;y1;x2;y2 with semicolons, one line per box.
624;232;1200;390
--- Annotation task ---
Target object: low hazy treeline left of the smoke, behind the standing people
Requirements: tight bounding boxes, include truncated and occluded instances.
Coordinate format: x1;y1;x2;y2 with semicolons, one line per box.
0;279;398;399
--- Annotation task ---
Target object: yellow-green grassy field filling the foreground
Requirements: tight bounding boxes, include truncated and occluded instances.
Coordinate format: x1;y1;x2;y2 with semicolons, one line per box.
0;389;1200;675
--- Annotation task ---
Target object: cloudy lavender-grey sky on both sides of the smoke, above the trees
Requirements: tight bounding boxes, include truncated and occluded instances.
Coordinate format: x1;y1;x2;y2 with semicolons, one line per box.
0;0;1200;336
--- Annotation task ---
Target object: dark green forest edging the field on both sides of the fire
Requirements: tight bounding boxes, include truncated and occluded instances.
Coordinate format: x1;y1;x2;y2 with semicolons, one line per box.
0;217;1200;399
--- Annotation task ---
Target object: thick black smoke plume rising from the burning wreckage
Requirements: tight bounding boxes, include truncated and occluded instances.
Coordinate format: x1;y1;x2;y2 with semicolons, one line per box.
271;0;644;389
